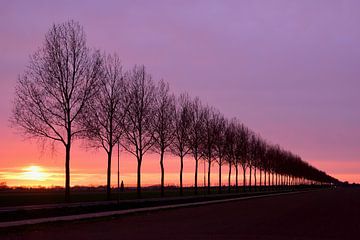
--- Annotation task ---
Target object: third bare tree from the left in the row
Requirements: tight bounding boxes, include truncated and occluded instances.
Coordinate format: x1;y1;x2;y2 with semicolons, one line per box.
122;66;155;197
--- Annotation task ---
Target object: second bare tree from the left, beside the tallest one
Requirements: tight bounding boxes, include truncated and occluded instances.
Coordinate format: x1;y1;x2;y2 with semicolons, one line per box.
81;55;128;200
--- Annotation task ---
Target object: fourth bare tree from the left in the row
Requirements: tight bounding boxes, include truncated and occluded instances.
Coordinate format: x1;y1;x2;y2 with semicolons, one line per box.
152;80;176;196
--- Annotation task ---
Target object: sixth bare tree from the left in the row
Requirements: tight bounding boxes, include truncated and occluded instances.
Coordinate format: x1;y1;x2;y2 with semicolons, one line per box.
188;98;204;194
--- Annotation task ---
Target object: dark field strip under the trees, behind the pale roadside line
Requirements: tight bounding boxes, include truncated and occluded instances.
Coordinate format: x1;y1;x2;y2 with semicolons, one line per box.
0;186;316;223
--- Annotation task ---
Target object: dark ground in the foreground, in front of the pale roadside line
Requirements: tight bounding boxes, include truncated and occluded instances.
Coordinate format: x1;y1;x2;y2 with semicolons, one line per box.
0;188;360;240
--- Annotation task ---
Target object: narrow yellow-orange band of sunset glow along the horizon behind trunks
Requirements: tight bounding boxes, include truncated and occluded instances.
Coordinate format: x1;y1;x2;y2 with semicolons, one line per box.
0;158;360;187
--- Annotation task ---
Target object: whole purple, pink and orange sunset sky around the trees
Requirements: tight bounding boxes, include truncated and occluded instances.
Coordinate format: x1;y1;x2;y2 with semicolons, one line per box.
0;0;360;186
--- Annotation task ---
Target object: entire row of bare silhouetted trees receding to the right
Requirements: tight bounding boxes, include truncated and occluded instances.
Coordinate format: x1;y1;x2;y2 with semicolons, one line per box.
11;21;335;200
